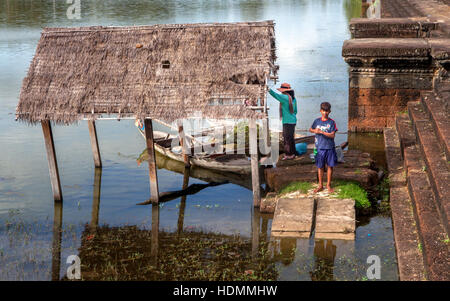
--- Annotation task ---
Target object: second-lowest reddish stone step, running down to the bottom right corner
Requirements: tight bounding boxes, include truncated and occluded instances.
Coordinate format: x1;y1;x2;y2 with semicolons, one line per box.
404;145;450;280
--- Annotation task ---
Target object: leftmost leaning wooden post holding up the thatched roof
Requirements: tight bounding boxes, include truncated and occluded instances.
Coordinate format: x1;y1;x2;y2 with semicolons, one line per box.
41;120;62;201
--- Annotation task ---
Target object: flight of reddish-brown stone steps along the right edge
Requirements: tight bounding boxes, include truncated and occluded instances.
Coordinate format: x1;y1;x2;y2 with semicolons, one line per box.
385;93;450;280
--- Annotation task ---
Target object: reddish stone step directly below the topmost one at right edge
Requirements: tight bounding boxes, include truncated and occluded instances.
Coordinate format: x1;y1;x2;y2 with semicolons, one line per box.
408;102;450;234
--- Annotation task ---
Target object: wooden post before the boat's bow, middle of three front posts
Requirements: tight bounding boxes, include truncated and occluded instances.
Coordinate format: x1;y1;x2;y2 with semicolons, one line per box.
144;119;159;204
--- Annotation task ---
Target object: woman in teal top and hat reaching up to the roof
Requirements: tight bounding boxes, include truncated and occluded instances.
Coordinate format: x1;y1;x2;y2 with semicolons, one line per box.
269;83;297;160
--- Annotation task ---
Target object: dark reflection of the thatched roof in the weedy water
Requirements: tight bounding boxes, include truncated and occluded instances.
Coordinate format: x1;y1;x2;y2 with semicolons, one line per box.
79;226;277;280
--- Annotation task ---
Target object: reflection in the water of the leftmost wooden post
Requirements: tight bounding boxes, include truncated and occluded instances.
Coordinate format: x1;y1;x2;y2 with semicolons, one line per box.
52;201;63;281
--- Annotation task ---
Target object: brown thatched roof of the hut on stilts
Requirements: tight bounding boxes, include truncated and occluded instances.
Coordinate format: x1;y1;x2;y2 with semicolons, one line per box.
16;21;276;123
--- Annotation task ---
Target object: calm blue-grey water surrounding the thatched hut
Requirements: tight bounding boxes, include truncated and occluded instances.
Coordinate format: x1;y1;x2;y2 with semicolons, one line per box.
0;0;397;280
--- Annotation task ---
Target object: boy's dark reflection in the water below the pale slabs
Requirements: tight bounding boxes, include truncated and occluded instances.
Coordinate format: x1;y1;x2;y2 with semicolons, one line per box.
309;240;336;281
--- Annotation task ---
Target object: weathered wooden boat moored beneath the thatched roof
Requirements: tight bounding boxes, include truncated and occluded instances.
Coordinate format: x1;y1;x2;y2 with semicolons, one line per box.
137;121;314;174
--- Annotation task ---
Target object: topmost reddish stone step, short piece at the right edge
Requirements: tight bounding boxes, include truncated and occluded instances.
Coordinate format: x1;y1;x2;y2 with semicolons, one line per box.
422;92;450;161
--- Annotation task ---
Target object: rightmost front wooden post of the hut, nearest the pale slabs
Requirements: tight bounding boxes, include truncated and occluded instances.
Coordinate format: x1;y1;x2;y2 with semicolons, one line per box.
249;119;261;207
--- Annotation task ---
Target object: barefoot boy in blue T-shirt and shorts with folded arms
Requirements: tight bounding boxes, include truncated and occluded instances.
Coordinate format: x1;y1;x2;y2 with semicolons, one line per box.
309;102;337;193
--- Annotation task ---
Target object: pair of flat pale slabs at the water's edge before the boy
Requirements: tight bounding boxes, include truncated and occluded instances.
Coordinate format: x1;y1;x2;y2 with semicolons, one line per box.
271;196;355;240
